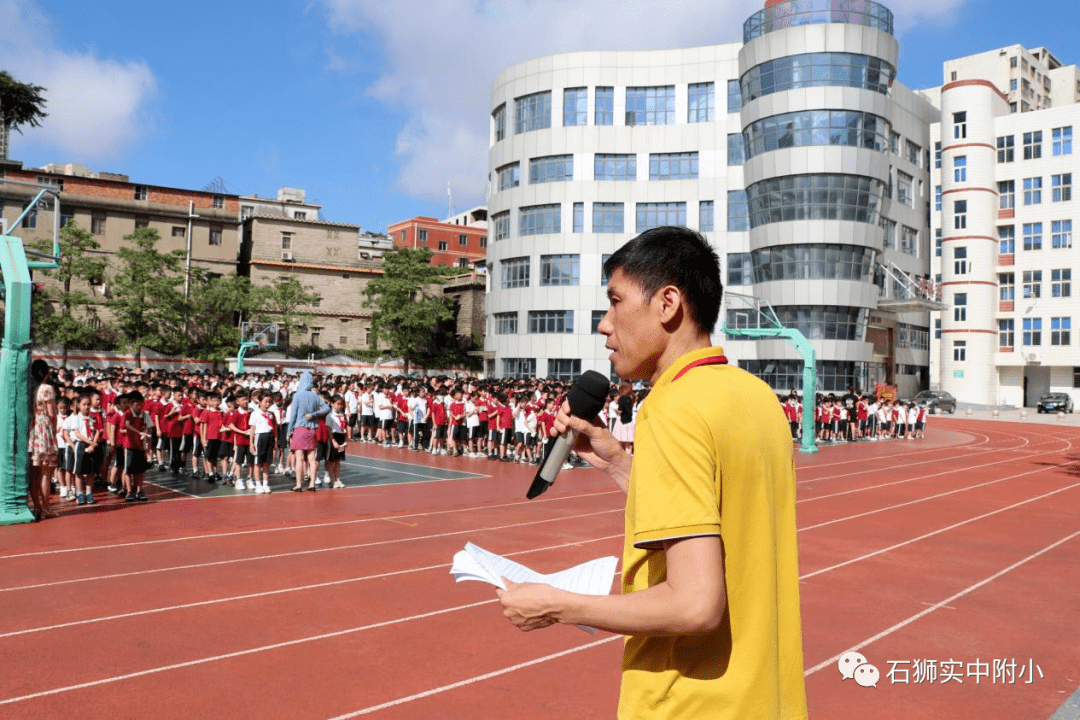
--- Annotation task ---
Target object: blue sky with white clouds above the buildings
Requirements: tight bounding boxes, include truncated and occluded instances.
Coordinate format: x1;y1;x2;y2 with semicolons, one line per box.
0;0;1080;230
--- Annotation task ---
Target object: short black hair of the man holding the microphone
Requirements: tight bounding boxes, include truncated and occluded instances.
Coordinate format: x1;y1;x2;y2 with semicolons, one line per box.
604;226;724;334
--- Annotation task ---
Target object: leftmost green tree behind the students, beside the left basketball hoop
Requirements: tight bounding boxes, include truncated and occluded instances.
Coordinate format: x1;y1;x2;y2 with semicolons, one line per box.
33;221;106;367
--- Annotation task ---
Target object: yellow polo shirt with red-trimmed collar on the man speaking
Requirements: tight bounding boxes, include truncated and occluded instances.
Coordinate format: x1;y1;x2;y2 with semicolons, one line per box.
619;348;807;720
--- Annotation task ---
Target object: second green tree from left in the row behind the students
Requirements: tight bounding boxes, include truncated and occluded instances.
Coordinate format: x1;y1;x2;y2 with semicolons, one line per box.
106;228;186;367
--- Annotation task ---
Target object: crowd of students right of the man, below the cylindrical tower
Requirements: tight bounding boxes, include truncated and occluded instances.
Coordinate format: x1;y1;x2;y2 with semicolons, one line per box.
778;388;930;443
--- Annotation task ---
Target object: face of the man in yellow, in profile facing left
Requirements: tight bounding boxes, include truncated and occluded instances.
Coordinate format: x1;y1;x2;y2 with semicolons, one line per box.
597;268;663;380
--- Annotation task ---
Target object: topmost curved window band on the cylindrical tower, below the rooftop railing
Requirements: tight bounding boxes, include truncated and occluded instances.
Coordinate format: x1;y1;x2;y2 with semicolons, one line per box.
740;53;896;103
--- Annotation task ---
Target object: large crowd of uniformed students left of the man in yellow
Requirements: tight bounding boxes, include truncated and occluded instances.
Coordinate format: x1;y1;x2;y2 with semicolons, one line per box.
30;366;642;517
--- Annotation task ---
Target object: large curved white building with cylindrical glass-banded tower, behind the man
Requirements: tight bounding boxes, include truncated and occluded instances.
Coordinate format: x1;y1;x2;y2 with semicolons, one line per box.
486;2;937;392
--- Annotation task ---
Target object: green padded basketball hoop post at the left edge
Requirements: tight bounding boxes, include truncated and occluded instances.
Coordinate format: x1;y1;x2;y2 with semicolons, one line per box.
0;235;33;525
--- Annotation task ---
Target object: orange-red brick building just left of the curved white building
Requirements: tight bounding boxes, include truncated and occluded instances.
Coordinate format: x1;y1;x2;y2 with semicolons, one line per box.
387;207;487;268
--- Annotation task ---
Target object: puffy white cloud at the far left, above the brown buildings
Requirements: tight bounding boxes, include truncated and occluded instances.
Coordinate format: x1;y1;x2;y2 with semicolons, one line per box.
0;0;157;162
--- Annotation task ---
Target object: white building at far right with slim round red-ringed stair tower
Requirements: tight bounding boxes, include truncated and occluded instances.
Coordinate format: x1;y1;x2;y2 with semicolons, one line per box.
931;45;1080;407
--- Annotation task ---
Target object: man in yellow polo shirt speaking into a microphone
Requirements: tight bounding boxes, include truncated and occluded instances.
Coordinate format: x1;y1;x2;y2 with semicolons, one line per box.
499;228;807;720
